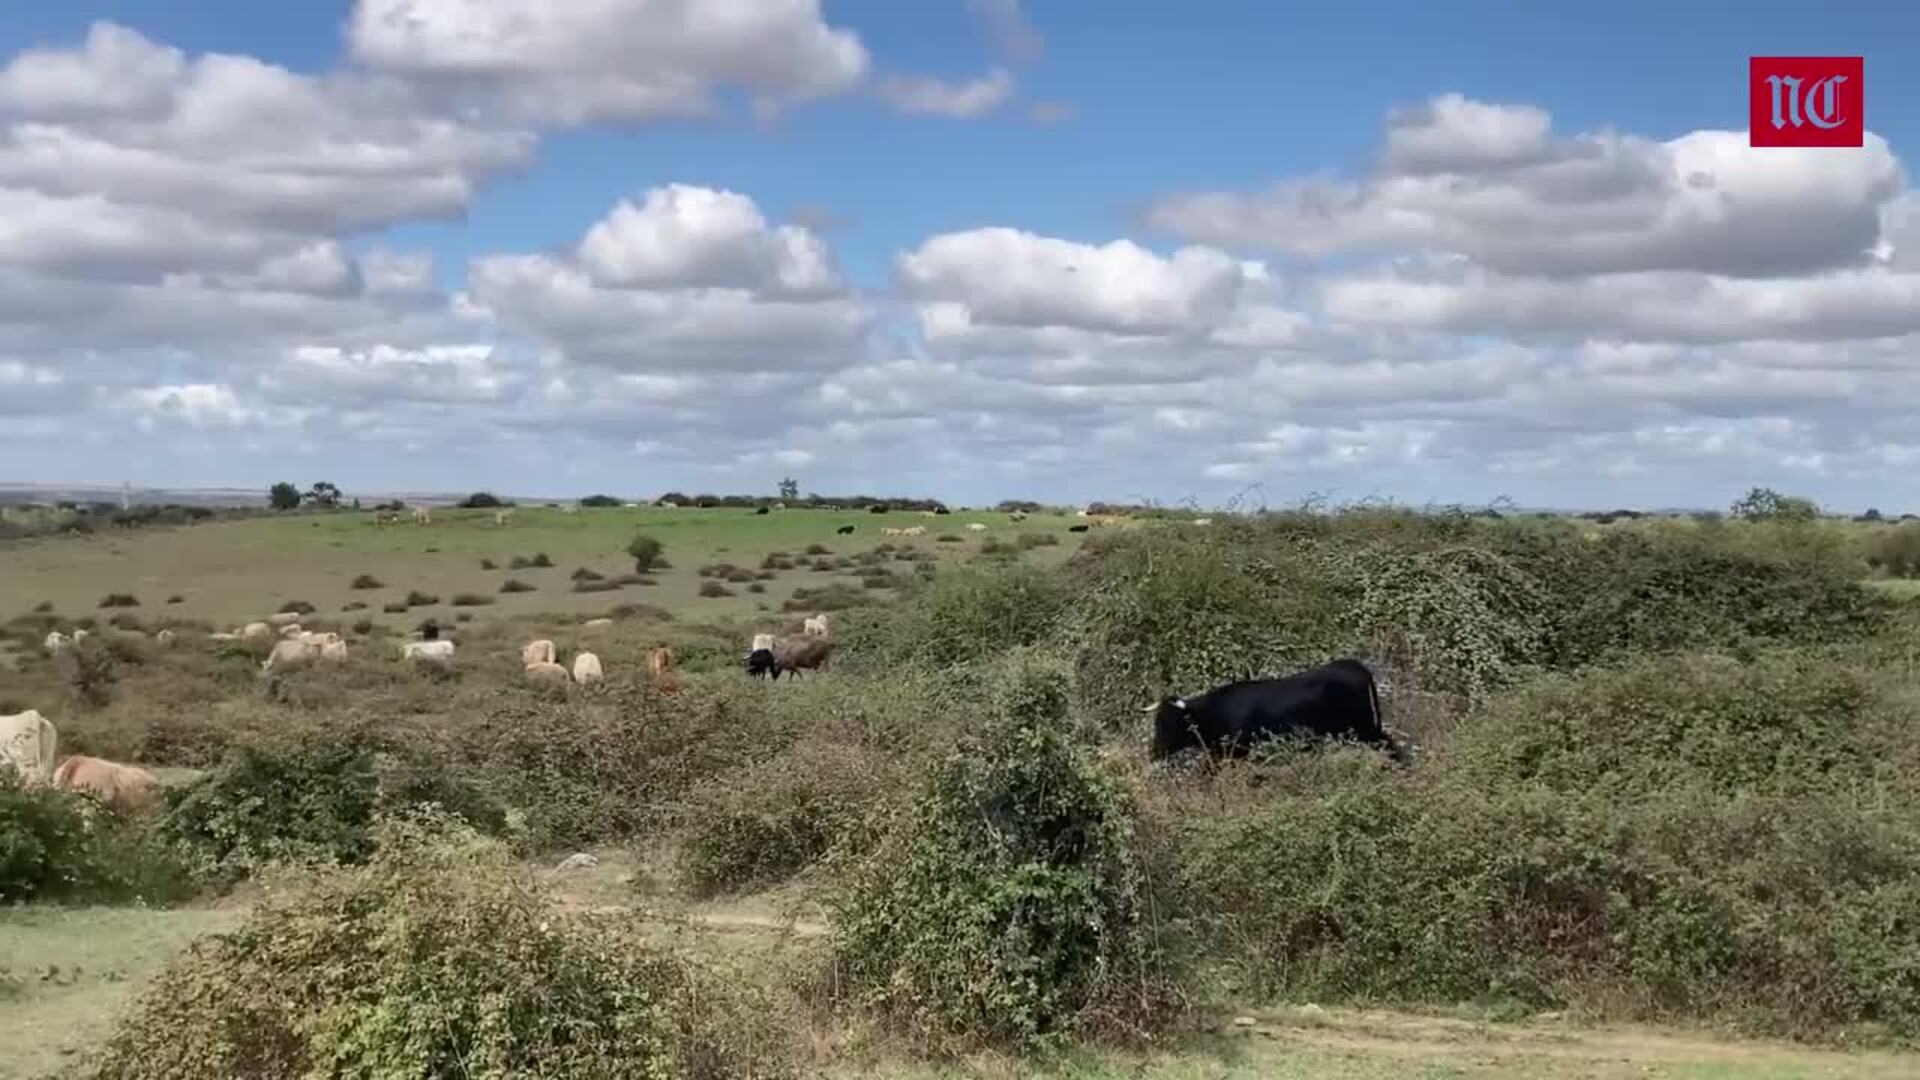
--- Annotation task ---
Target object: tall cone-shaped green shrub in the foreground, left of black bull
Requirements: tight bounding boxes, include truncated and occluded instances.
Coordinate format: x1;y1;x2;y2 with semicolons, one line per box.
833;665;1175;1045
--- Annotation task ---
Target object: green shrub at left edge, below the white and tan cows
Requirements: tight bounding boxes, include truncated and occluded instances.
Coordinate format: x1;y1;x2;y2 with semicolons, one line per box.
0;769;190;903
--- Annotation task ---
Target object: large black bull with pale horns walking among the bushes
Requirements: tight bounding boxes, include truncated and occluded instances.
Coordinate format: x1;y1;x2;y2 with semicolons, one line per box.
1140;659;1404;761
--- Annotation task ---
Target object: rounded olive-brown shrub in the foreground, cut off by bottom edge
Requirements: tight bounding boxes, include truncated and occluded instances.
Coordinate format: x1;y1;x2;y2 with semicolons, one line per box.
92;821;793;1080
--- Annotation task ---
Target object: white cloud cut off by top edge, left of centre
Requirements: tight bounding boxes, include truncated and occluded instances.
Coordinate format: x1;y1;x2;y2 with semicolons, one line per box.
348;0;868;125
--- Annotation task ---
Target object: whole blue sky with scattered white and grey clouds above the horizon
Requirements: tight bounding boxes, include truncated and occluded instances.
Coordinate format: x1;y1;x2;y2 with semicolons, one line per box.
0;0;1920;513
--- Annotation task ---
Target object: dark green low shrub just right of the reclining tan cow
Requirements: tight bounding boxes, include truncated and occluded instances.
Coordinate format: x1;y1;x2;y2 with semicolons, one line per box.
161;728;505;880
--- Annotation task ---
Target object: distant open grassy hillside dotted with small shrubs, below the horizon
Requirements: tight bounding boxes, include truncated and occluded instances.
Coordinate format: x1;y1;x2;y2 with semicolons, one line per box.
0;507;1081;628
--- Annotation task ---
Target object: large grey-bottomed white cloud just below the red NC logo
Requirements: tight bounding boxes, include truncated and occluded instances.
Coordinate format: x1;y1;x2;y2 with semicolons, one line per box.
1146;94;1907;277
